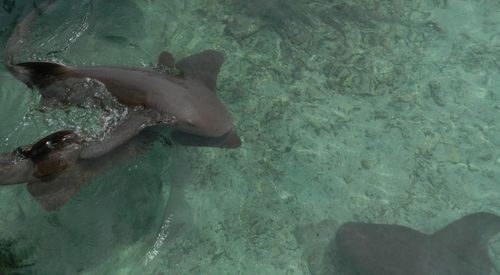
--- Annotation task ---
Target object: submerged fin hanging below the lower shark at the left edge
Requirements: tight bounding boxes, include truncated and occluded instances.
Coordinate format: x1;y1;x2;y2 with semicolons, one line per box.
27;171;85;211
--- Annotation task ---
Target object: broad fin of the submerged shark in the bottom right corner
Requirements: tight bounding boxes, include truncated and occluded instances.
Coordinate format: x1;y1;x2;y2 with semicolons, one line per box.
431;212;500;274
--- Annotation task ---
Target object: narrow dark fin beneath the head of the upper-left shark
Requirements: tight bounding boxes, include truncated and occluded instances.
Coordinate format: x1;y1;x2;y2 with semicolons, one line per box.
171;130;241;149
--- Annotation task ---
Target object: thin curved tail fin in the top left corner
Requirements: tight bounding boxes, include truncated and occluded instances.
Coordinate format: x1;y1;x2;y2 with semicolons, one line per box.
4;0;54;85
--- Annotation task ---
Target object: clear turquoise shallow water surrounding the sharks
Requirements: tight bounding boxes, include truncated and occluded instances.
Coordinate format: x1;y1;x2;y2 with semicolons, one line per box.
0;0;500;274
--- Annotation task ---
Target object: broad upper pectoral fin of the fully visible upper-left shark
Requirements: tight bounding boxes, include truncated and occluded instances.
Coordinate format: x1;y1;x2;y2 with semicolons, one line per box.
175;50;224;91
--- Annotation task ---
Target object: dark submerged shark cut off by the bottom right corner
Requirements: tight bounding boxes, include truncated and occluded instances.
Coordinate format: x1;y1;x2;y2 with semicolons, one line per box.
335;212;500;275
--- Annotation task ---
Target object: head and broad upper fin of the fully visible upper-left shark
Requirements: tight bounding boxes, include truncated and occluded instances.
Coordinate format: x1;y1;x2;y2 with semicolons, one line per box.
159;50;241;148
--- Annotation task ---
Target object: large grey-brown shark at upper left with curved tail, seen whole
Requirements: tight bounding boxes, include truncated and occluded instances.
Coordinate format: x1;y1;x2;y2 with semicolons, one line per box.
4;0;241;155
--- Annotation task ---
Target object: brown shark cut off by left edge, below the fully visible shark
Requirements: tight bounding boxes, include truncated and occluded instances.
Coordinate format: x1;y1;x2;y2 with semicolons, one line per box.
0;129;168;211
